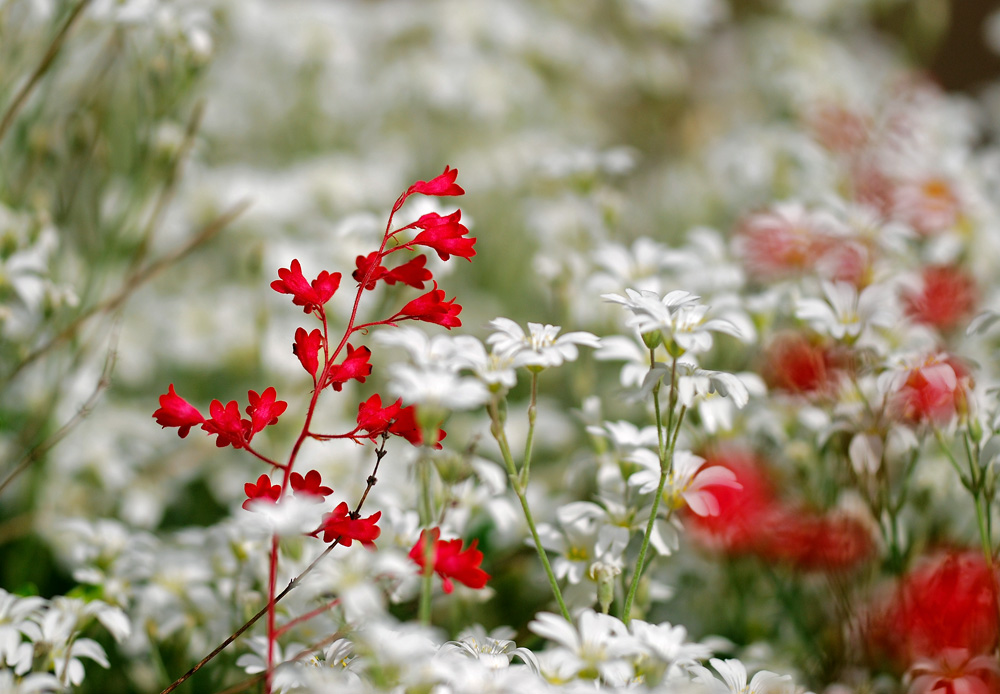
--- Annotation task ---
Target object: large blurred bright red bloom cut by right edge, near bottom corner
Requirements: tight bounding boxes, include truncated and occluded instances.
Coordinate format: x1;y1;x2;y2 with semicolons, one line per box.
867;551;1000;670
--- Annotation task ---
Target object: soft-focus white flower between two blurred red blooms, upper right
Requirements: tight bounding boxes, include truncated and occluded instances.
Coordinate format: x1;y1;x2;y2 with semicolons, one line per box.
795;282;897;342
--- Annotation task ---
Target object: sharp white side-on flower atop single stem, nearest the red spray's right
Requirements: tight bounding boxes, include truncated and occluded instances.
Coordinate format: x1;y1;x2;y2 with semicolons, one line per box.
486;317;601;371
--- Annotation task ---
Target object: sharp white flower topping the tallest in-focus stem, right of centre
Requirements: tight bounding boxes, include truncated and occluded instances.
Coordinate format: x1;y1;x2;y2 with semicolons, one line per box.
601;289;746;356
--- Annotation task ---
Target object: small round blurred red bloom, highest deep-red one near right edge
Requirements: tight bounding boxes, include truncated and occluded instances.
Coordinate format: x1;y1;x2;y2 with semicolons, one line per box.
903;265;979;331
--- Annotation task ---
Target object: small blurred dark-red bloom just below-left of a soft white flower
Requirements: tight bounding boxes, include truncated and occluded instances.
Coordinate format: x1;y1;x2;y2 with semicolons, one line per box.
762;333;836;393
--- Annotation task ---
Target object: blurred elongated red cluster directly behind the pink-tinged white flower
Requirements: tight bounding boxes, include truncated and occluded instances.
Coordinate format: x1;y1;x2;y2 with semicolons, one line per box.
688;449;875;571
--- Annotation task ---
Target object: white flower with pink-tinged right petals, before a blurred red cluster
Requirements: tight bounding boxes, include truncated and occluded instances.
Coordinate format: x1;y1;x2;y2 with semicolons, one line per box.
628;448;743;516
